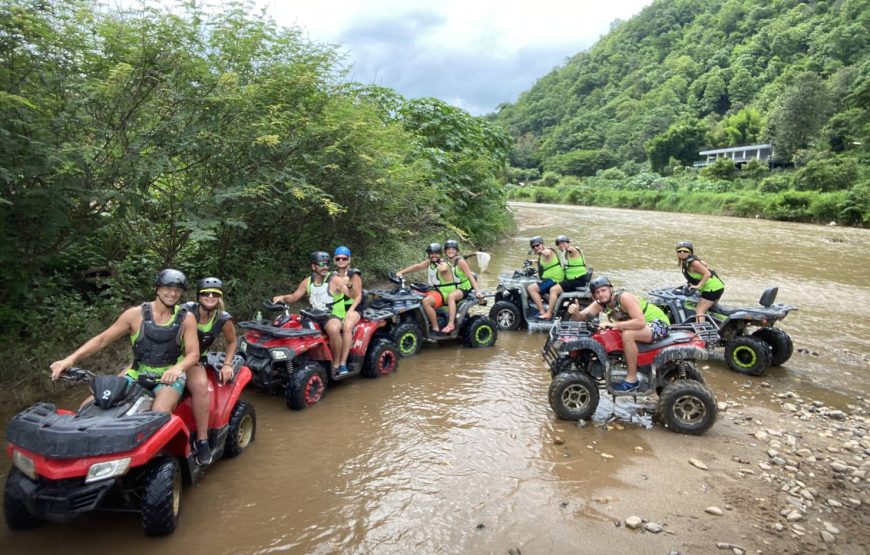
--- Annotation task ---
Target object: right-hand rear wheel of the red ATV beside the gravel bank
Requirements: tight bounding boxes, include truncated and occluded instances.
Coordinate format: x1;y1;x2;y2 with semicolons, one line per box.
659;380;718;436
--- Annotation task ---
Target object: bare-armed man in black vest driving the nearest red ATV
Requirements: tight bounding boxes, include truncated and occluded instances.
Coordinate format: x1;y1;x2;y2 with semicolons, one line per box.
51;269;201;412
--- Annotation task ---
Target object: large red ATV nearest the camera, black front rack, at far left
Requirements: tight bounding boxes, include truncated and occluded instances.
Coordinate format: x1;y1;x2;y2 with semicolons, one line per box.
3;357;257;536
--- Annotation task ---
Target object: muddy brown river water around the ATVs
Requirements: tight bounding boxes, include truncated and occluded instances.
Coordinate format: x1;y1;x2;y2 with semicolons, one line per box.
0;204;870;555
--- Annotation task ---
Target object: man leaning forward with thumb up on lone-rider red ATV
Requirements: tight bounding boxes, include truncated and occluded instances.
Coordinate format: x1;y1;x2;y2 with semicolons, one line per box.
568;276;671;391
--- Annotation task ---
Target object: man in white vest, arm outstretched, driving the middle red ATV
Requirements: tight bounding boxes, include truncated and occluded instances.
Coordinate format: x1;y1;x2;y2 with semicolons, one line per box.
272;251;350;374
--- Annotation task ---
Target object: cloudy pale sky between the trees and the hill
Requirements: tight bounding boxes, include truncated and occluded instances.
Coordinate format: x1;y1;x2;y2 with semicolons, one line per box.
256;0;652;115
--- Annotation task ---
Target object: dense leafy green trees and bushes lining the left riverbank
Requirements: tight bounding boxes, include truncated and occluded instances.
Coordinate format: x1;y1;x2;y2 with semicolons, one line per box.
0;0;513;390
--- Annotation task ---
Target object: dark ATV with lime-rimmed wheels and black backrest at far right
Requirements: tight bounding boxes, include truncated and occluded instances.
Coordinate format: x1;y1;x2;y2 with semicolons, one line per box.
648;287;797;376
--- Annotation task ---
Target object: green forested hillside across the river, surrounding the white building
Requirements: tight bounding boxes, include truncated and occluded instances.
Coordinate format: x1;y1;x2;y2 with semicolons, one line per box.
493;0;870;226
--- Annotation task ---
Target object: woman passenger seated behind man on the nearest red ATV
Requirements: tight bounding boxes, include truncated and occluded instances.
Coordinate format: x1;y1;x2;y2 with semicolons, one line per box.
184;277;236;465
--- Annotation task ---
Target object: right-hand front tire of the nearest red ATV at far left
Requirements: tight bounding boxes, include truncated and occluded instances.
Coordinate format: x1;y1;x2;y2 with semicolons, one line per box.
142;458;181;536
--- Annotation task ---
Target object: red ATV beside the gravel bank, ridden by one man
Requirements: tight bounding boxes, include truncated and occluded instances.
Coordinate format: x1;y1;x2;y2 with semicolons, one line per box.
543;321;718;435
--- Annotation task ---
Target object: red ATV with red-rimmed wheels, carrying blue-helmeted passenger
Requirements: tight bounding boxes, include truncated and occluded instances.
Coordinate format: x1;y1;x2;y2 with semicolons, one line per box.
239;301;399;410
